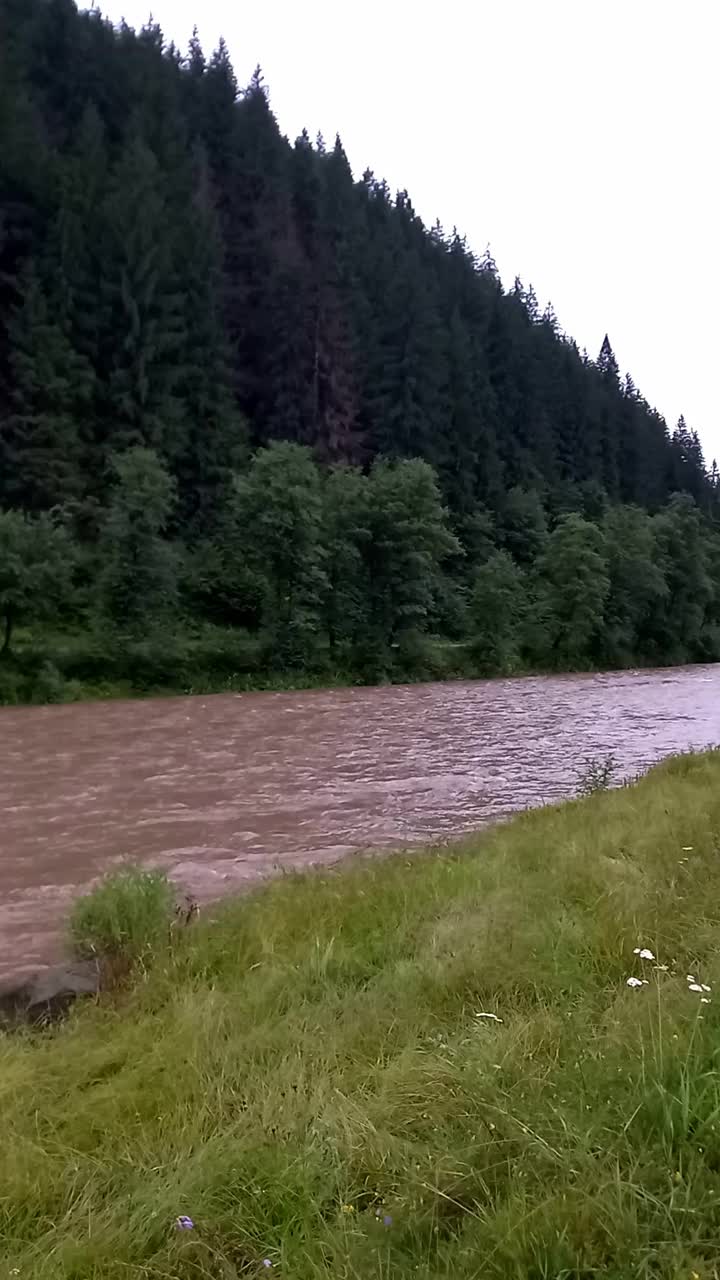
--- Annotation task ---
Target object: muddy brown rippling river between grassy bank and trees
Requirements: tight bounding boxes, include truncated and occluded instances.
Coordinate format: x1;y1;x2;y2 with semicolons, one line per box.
0;666;720;977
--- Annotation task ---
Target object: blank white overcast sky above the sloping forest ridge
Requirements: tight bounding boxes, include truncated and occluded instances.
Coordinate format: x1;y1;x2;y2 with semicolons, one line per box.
101;0;720;461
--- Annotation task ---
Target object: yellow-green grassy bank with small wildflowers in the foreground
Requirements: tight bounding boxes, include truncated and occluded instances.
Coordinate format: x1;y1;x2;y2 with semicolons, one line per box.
0;753;720;1280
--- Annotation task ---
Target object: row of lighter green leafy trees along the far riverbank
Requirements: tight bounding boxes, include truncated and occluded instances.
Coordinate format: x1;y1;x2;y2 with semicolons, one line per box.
0;442;720;689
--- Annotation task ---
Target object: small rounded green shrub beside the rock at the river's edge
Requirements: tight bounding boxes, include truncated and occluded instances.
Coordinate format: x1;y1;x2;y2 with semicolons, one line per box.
70;867;176;982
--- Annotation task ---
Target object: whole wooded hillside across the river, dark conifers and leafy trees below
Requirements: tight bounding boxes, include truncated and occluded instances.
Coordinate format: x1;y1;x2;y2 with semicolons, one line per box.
0;0;720;701
